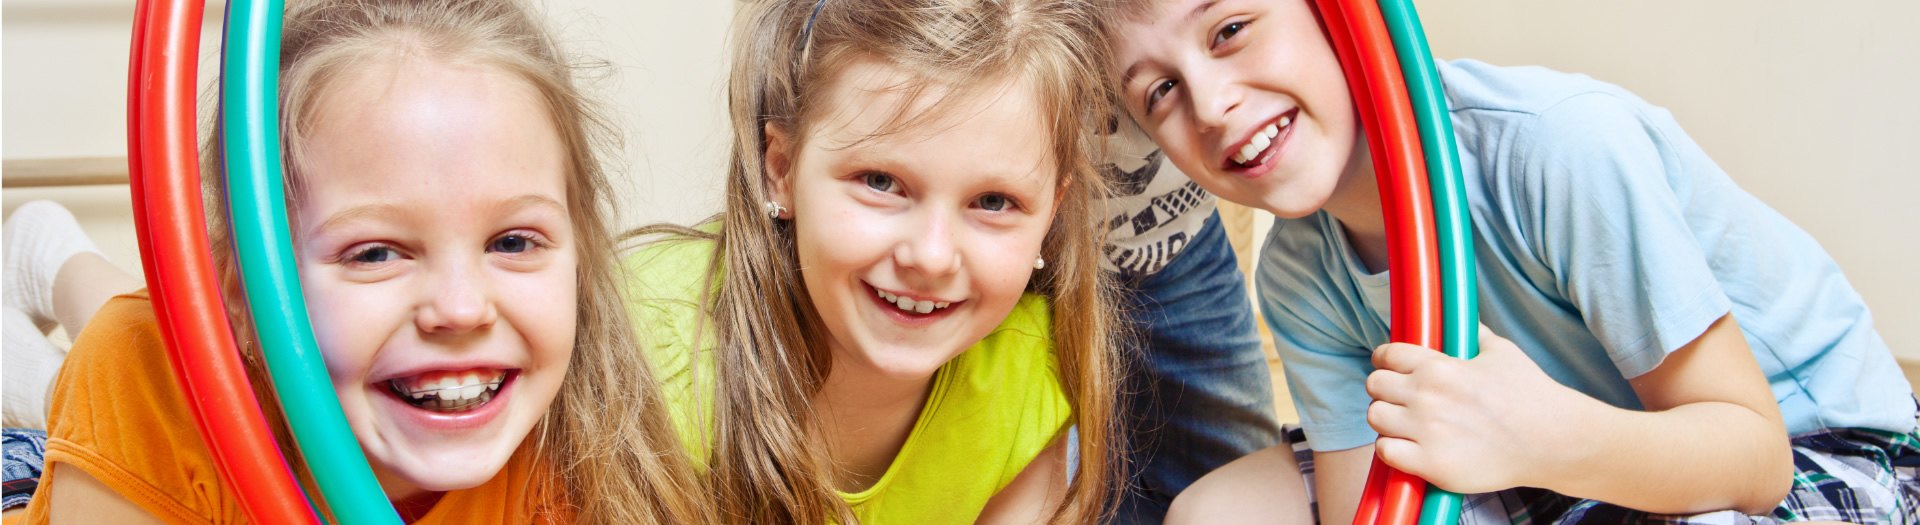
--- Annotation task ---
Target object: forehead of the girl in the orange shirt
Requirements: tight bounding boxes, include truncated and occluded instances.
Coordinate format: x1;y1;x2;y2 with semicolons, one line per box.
300;58;570;212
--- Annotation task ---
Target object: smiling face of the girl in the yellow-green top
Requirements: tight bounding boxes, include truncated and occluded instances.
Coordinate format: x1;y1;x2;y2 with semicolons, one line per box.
766;60;1060;379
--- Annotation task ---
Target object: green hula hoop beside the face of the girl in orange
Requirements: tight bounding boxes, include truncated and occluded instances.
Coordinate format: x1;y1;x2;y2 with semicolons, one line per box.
221;0;399;525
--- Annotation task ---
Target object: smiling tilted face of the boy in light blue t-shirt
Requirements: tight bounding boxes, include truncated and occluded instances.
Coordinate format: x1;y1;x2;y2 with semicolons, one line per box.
1112;0;1359;217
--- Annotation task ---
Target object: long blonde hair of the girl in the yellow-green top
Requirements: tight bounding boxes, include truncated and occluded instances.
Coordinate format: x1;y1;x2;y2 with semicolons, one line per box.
639;0;1121;523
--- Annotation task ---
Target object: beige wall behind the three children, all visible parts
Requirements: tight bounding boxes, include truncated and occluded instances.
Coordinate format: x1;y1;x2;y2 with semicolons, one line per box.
0;0;1920;358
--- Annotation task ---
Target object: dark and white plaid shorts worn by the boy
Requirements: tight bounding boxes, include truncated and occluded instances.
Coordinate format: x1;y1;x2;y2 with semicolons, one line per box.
1286;425;1920;525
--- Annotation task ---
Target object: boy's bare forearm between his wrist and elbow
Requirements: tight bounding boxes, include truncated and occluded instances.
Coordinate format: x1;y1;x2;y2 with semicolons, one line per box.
1534;394;1793;513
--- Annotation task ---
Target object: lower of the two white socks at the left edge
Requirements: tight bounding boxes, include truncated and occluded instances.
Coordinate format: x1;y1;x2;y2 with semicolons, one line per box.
0;308;67;431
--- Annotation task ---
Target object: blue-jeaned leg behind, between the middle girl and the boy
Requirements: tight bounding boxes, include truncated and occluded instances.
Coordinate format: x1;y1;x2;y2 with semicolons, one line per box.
1117;213;1281;523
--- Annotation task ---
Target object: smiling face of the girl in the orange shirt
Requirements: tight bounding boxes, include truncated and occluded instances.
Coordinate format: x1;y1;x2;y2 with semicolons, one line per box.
294;58;578;500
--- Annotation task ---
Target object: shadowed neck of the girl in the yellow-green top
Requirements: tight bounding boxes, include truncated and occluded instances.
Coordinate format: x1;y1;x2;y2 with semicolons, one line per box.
814;352;933;492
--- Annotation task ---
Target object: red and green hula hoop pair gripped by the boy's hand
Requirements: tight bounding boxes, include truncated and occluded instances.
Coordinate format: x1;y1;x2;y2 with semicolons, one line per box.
1315;0;1480;525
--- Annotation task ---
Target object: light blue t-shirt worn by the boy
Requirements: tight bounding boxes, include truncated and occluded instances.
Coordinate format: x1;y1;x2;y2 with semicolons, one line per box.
1258;60;1914;450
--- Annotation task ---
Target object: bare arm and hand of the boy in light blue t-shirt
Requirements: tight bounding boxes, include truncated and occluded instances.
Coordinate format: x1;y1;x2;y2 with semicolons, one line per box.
1367;315;1793;513
